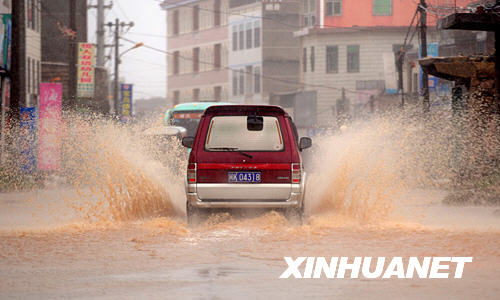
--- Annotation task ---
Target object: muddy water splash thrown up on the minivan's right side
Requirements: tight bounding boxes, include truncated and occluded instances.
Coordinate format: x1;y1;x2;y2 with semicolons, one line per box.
306;104;500;222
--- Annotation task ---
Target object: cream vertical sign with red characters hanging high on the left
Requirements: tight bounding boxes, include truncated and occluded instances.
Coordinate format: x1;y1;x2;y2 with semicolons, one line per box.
77;43;95;98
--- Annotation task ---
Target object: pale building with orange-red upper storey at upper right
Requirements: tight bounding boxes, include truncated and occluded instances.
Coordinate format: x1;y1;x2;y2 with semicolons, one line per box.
295;0;478;126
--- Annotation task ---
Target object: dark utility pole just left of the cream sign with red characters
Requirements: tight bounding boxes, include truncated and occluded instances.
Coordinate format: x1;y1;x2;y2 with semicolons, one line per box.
67;0;77;108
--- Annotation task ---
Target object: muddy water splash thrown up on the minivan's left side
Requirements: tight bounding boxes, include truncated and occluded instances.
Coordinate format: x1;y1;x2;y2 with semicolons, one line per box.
57;113;185;221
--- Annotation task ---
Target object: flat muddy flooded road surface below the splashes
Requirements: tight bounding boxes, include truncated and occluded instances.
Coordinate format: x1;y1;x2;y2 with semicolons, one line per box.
0;191;500;299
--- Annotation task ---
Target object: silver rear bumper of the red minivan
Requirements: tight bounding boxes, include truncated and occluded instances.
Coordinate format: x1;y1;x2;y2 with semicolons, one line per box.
186;184;304;208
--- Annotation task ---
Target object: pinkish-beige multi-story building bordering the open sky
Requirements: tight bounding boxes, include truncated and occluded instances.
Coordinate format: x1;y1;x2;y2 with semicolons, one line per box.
161;0;229;105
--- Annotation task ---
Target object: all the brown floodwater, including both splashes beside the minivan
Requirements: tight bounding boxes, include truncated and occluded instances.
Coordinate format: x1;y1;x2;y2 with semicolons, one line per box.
0;111;500;299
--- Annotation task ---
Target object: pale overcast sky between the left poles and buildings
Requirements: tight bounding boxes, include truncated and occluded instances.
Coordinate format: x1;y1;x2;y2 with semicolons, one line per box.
88;0;166;100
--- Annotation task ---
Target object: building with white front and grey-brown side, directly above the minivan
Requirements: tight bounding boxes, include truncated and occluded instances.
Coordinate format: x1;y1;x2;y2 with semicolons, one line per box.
229;0;301;104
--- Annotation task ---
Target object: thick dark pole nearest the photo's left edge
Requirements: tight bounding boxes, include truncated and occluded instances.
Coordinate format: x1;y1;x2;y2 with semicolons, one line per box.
10;1;26;122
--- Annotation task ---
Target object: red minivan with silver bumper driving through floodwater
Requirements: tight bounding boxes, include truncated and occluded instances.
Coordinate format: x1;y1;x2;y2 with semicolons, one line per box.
182;105;312;223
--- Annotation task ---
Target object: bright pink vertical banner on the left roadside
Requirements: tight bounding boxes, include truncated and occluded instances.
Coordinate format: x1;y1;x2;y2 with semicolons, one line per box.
38;83;62;171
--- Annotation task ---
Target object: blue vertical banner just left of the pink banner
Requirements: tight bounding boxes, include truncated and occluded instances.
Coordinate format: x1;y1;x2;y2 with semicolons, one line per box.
19;107;36;173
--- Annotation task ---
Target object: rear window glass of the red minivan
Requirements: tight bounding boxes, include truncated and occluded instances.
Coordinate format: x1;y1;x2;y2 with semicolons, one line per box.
205;116;284;151
